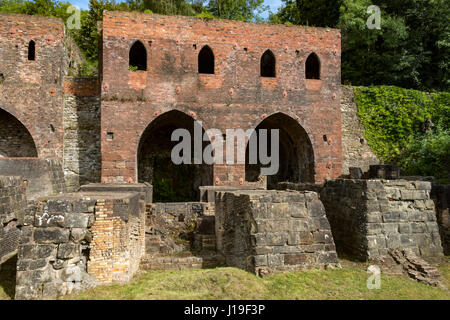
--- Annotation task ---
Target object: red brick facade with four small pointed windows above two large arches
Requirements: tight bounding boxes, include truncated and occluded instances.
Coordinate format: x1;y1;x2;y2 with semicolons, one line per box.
101;12;342;185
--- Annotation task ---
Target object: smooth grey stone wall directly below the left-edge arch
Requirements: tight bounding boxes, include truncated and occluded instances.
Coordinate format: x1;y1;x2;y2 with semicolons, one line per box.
0;158;66;200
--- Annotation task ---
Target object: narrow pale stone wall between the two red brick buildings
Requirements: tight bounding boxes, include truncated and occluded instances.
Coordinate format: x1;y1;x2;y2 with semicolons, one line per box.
63;77;101;191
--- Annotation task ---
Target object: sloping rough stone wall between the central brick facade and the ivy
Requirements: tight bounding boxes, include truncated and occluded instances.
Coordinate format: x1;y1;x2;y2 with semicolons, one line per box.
341;86;380;175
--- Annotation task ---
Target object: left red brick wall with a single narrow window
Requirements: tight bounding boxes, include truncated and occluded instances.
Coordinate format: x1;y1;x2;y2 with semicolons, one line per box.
0;14;65;159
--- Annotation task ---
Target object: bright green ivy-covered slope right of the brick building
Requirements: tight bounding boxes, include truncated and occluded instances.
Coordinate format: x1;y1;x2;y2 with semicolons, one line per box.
354;86;450;183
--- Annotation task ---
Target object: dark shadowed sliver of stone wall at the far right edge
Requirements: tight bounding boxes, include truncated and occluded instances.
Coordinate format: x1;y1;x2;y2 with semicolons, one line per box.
431;183;450;255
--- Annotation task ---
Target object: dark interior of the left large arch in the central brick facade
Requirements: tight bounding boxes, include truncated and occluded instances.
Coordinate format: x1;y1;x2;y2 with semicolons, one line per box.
137;110;213;202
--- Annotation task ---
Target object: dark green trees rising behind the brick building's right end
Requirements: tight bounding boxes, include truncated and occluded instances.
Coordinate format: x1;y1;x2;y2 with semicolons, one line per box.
269;0;450;91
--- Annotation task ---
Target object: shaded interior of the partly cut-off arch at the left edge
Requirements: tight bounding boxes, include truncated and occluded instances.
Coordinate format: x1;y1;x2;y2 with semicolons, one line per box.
0;109;38;157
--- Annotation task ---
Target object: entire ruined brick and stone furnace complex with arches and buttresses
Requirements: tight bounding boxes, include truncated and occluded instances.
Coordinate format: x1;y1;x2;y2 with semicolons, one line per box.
0;11;448;299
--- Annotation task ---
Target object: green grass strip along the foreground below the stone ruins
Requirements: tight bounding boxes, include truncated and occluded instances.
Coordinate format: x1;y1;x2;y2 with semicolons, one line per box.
0;257;450;300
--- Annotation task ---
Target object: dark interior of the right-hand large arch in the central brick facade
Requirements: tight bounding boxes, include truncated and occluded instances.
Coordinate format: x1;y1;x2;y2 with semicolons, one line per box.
245;113;314;189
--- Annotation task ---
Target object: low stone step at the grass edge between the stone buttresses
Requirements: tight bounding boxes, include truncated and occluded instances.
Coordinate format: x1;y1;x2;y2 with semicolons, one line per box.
140;254;225;270
